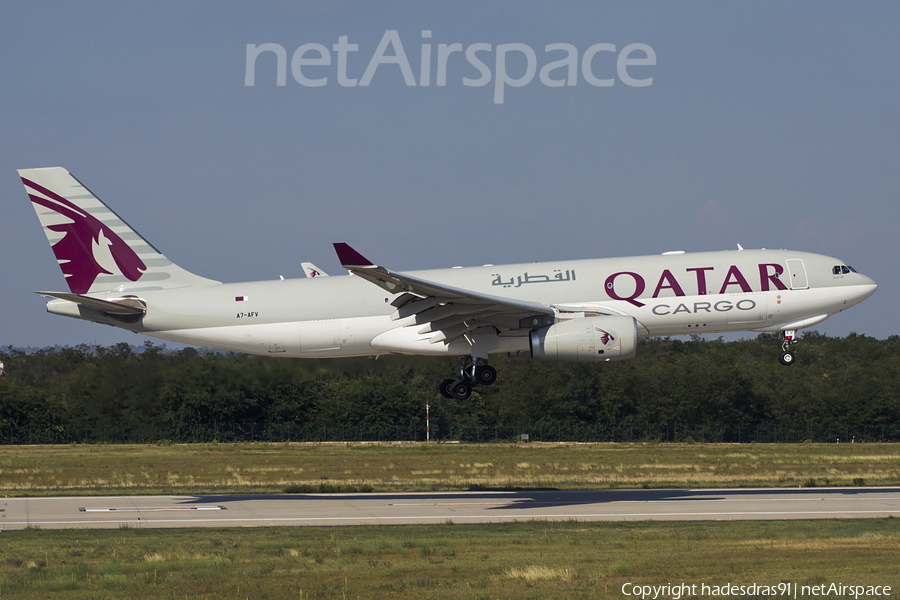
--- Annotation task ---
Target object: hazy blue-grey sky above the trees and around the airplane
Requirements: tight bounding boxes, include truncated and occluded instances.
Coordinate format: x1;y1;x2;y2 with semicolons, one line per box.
0;1;900;346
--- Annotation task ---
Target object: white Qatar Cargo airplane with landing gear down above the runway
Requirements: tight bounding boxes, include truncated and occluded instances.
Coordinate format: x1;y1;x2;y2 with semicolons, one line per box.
19;167;877;400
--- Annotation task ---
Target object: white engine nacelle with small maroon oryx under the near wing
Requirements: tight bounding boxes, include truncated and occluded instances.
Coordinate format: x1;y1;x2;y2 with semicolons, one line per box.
531;315;637;362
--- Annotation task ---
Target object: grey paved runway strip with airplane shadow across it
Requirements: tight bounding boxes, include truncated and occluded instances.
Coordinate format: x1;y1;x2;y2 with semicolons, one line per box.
0;487;900;531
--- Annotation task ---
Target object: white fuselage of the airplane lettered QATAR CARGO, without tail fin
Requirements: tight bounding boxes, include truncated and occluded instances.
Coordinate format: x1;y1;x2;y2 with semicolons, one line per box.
48;250;876;357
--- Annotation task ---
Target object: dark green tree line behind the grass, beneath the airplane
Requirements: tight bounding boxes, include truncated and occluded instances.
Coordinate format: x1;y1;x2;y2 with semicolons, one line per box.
0;332;900;438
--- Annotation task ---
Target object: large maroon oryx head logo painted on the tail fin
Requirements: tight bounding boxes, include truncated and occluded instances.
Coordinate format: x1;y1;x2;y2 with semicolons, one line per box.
22;177;147;294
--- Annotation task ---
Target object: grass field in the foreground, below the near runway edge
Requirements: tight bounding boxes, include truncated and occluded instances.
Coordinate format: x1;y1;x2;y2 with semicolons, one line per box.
0;519;900;600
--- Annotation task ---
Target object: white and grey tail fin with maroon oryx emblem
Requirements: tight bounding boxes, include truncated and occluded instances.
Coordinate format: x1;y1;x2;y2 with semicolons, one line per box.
19;167;218;294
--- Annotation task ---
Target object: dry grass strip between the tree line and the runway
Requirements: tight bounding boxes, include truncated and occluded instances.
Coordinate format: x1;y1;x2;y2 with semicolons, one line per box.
0;443;900;496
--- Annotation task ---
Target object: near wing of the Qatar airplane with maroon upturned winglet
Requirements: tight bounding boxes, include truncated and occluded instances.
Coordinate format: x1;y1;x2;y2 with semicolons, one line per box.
334;242;556;344
